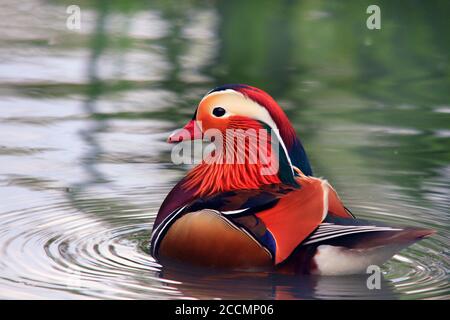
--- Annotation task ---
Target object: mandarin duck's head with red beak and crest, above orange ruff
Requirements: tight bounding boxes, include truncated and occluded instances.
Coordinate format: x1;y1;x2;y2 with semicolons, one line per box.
168;84;312;175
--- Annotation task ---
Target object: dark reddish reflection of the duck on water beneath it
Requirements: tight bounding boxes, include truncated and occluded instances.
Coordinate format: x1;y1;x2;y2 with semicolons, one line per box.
160;263;396;300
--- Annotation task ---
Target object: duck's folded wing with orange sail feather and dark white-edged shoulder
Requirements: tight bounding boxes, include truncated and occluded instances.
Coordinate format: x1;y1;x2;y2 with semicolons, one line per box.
151;177;329;264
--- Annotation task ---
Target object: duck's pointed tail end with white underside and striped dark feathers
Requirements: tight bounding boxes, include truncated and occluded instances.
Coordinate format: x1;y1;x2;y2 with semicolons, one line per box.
278;214;434;275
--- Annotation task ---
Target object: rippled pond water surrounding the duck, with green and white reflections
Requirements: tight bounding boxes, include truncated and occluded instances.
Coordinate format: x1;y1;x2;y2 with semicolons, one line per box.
0;0;450;299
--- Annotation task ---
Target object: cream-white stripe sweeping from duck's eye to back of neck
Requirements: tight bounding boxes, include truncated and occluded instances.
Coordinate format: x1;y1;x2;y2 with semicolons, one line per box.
200;89;294;173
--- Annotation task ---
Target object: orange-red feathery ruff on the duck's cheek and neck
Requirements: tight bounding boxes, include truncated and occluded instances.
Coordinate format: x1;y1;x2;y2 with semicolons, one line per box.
184;124;295;196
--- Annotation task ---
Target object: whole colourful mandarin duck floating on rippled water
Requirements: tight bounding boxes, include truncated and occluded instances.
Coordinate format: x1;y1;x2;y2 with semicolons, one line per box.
151;85;433;275
